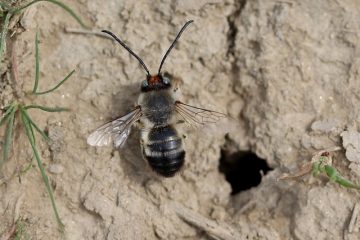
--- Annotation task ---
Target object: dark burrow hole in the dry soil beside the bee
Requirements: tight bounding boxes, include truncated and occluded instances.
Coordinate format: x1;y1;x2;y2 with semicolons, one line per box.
219;150;272;195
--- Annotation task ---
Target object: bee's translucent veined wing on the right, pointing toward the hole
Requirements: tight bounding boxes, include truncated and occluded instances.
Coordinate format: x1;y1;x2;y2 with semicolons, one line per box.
175;101;226;126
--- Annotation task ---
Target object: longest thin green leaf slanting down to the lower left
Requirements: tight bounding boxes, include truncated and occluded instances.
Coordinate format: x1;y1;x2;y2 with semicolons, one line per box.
21;109;64;231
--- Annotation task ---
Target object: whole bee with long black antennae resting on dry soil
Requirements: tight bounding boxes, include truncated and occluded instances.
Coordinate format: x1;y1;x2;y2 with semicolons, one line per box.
87;20;225;177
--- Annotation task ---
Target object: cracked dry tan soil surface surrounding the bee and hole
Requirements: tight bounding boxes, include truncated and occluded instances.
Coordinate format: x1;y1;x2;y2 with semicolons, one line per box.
0;0;360;240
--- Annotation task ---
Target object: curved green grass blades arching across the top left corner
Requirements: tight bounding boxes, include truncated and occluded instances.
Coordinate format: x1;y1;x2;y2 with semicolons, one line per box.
0;0;87;61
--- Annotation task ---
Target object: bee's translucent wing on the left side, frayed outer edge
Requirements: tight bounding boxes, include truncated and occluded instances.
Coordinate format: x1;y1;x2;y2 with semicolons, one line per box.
87;107;141;148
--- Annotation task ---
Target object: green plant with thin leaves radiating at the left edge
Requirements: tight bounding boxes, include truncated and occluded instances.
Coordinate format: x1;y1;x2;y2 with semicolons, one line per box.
0;31;75;230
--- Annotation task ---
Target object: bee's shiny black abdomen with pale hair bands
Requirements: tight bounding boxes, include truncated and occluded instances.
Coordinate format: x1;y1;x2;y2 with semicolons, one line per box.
143;125;185;177
